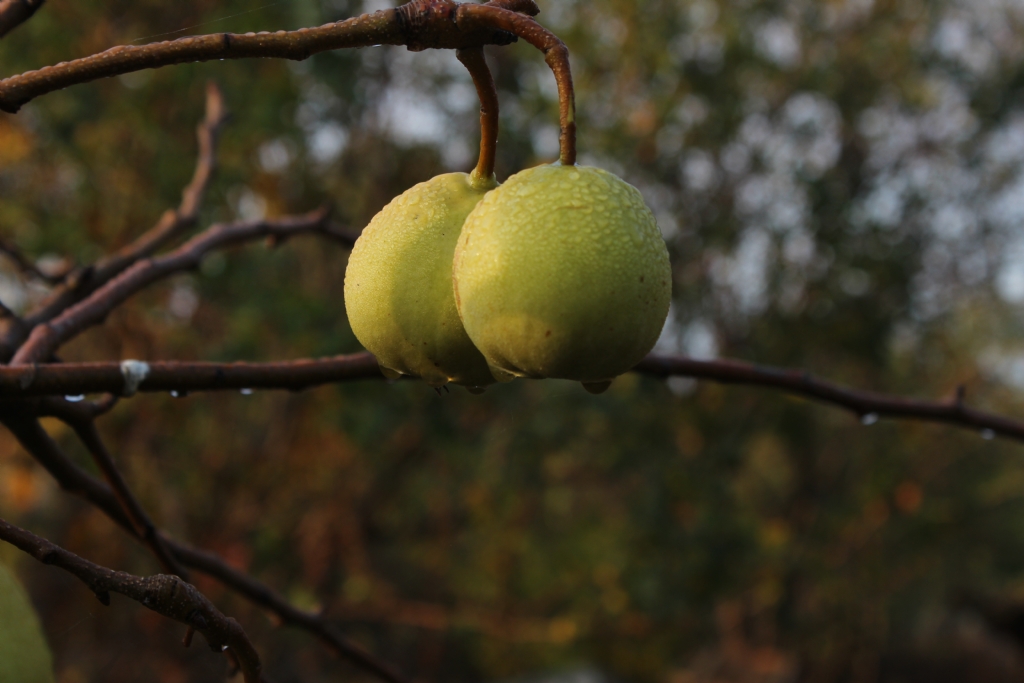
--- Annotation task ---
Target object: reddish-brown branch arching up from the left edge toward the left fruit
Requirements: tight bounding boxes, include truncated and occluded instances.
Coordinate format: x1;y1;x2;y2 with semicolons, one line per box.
11;210;347;365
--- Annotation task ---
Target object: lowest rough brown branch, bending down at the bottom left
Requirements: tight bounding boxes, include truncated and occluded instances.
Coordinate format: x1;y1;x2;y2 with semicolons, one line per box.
0;519;261;683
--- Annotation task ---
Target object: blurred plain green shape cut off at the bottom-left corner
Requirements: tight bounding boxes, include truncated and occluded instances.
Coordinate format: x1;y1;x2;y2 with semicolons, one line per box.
0;563;53;683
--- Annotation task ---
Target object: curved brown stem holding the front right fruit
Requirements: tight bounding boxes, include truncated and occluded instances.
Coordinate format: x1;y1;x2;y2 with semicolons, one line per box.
456;3;577;166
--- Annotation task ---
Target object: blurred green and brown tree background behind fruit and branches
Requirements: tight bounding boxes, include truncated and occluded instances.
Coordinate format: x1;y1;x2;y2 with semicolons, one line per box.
6;0;1024;683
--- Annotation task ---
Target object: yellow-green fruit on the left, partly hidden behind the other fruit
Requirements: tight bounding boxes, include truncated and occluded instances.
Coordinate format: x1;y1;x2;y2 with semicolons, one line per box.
345;173;497;387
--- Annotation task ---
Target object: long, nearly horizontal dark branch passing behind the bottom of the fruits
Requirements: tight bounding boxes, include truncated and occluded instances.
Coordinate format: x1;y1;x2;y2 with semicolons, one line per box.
0;353;1024;440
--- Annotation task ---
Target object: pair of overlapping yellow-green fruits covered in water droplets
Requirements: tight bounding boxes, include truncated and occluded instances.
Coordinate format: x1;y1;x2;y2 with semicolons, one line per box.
345;164;672;391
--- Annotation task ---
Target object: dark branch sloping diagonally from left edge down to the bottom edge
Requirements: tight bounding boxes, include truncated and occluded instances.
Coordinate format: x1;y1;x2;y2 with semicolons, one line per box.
0;413;408;683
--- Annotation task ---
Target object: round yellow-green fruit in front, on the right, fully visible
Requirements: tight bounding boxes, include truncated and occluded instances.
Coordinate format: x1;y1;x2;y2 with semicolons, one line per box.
454;165;672;383
